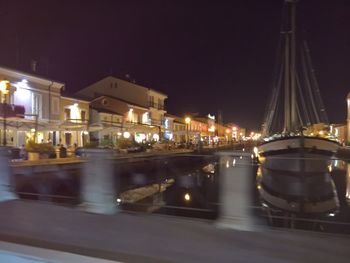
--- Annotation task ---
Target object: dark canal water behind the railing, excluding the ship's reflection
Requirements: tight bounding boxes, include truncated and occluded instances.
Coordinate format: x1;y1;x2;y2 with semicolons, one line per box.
14;155;350;234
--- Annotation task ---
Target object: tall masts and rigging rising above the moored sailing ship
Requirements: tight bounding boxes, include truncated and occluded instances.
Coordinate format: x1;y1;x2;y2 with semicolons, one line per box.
264;0;328;135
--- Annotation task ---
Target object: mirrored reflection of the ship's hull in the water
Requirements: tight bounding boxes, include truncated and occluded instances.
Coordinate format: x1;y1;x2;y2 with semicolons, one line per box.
257;166;339;217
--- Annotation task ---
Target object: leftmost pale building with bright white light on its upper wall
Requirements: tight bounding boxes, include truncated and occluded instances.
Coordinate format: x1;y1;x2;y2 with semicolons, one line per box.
0;67;64;146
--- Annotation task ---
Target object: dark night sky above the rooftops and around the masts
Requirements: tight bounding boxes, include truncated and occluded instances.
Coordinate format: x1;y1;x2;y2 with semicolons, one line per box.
0;0;350;129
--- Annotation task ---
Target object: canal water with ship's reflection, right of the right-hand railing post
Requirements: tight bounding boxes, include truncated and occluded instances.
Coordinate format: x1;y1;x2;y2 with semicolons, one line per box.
257;156;350;234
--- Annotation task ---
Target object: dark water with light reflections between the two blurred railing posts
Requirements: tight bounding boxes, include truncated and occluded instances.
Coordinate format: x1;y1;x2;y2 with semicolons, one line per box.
118;156;220;219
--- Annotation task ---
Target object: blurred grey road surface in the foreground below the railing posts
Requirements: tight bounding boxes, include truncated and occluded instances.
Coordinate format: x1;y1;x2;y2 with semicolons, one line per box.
0;200;350;263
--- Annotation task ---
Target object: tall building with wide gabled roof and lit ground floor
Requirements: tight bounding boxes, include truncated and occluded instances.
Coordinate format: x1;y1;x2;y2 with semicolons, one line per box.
76;76;169;142
